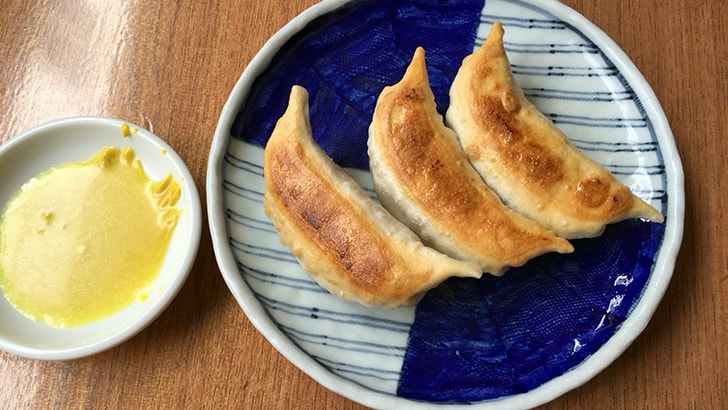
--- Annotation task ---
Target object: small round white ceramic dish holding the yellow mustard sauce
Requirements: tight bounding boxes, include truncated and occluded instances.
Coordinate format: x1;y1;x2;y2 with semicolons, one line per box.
0;117;202;360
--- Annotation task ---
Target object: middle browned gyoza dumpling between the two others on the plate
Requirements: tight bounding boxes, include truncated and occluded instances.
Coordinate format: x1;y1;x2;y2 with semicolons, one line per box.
368;48;574;275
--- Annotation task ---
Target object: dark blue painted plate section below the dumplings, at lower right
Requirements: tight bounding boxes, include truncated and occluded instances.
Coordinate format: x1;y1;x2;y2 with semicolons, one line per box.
399;221;664;402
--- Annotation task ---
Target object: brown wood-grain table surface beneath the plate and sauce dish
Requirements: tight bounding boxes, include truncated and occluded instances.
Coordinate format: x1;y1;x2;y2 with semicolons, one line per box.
0;0;728;409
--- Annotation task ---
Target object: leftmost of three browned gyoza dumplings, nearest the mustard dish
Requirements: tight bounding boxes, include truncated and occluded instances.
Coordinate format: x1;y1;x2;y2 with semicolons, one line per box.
263;86;482;307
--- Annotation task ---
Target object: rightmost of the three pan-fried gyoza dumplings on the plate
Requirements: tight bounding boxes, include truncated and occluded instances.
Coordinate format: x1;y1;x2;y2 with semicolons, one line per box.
446;22;663;239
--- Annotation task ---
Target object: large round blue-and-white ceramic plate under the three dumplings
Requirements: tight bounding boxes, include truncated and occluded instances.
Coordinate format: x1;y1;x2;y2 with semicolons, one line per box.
207;0;684;408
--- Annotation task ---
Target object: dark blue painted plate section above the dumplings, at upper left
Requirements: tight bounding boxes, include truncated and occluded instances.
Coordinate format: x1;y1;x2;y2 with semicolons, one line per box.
231;0;483;169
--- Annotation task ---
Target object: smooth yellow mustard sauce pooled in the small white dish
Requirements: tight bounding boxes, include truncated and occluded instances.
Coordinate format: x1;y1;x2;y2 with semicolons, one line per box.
0;147;182;328
